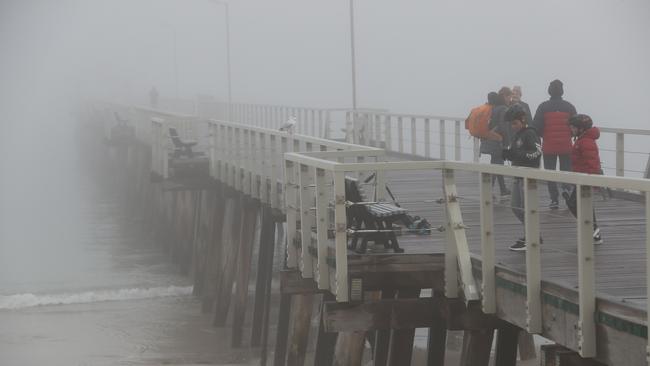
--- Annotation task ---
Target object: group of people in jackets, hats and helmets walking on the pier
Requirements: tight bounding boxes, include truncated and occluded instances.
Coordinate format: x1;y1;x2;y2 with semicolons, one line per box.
480;80;603;251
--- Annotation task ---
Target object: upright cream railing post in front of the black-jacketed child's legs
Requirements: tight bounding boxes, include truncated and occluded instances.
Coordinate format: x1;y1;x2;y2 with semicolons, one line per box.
515;178;542;333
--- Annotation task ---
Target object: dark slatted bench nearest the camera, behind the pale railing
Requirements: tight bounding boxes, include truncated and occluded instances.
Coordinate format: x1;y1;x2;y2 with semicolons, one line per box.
345;177;408;253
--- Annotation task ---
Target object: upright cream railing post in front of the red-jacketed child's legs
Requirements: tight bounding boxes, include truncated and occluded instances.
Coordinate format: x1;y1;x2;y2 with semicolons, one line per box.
576;185;596;357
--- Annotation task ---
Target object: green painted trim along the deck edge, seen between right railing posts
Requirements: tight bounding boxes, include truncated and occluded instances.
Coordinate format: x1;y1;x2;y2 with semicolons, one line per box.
496;277;648;339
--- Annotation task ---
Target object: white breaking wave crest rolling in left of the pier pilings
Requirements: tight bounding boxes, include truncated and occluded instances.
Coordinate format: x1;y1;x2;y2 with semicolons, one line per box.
0;286;192;310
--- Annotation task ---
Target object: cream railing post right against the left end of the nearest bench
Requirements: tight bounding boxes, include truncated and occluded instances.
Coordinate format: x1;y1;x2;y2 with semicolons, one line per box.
334;172;349;302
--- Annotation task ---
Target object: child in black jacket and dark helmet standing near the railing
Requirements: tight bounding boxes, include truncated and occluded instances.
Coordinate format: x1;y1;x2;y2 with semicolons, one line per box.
503;104;542;251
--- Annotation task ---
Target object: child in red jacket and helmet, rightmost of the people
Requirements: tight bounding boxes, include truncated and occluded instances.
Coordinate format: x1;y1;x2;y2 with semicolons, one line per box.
562;114;603;244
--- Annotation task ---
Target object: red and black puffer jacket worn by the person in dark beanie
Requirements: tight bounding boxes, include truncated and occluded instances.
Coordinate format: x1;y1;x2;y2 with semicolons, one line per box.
533;95;576;155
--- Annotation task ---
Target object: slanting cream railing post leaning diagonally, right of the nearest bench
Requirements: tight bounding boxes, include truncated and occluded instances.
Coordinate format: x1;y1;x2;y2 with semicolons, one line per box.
443;169;479;301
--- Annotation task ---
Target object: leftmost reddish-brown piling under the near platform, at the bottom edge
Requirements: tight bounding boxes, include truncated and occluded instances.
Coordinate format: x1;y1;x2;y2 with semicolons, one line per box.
287;295;314;366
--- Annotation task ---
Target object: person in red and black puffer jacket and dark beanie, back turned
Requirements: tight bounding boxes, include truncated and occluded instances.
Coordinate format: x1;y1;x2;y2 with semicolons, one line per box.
533;80;576;210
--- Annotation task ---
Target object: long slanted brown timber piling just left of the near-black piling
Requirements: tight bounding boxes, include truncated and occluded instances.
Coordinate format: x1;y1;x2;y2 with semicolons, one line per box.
231;200;259;347
